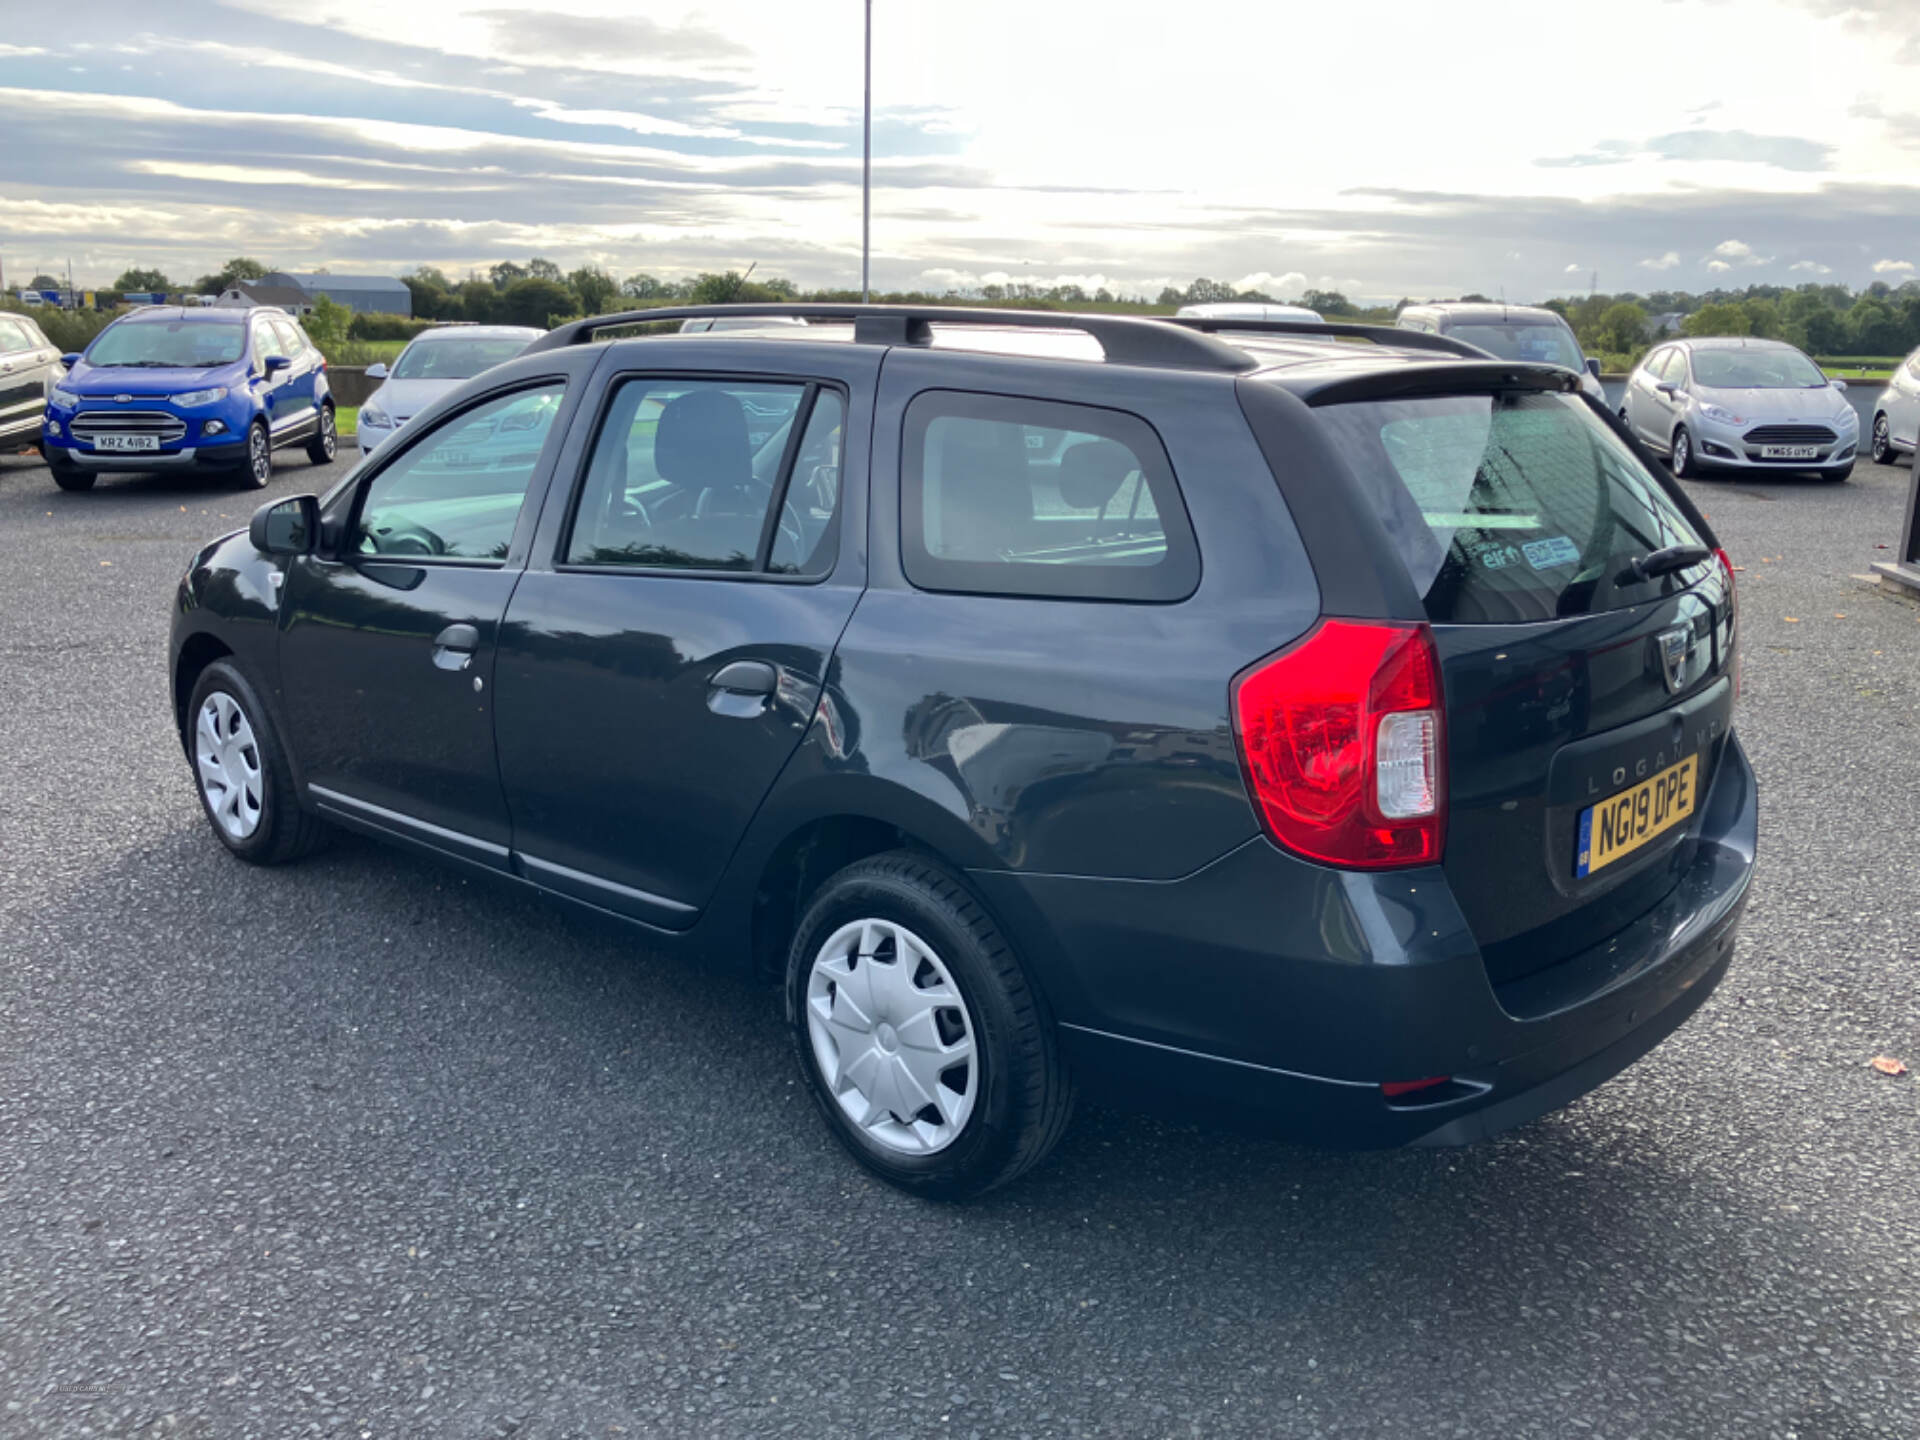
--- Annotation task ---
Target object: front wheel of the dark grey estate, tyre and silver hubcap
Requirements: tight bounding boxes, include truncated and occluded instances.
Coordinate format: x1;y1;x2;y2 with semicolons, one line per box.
186;660;326;866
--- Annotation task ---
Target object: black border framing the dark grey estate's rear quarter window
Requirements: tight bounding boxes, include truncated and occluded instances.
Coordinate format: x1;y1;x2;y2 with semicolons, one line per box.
899;386;1202;605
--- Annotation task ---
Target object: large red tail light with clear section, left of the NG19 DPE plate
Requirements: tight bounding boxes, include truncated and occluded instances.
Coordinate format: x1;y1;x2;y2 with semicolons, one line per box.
1233;620;1446;870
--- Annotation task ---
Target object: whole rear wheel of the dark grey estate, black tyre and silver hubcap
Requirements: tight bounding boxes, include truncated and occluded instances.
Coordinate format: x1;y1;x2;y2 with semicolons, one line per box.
787;851;1073;1200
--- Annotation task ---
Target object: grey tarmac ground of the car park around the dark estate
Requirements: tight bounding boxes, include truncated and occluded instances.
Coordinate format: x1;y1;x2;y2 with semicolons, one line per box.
0;445;1920;1440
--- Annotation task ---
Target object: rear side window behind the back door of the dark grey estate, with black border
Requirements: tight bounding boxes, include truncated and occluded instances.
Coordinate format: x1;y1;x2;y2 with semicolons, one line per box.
900;390;1200;601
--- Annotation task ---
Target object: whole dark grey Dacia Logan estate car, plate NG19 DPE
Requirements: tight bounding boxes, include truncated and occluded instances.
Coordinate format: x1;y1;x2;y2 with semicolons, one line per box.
169;305;1759;1196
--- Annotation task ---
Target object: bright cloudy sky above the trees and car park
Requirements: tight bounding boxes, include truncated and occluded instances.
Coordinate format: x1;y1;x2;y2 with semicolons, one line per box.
0;0;1920;300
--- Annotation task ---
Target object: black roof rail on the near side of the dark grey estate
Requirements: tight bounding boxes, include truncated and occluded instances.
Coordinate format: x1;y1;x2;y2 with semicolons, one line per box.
522;301;1258;374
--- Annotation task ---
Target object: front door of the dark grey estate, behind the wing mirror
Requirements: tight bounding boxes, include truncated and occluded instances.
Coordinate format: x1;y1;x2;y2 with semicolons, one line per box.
280;374;576;868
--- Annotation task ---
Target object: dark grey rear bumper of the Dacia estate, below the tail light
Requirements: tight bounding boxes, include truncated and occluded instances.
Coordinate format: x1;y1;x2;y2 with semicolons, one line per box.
975;737;1759;1148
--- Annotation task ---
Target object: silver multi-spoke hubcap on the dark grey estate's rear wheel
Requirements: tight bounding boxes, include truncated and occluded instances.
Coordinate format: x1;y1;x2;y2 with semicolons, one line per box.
806;920;979;1154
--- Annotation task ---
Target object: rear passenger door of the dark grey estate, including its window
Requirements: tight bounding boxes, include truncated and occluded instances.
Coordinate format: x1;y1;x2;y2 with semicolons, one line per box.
495;351;881;929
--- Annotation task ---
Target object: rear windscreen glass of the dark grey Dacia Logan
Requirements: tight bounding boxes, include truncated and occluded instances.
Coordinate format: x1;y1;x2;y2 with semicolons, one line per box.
1315;390;1701;624
